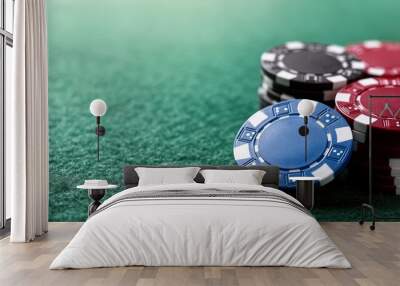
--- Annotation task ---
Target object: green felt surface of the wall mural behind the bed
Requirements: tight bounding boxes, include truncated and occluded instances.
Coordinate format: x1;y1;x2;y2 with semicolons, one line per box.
47;0;400;221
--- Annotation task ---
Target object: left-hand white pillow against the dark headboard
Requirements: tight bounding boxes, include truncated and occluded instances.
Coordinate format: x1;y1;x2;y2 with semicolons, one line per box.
135;167;200;186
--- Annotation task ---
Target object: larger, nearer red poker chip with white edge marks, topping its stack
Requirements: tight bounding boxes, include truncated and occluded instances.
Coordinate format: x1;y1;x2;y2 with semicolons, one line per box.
335;78;400;133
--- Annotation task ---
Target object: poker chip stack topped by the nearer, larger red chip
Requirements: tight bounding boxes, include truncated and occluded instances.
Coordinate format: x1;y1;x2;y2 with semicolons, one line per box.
335;77;400;193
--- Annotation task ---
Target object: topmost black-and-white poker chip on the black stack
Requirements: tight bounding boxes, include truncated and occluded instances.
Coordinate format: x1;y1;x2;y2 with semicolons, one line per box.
261;42;365;90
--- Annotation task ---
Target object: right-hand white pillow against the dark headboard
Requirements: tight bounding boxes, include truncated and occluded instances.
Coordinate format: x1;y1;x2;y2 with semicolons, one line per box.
200;169;265;185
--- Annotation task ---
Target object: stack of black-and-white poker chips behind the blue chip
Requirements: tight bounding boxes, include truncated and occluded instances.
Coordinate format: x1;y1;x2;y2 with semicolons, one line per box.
258;42;365;108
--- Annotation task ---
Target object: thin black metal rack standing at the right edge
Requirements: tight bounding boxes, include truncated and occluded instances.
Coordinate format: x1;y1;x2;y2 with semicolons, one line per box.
359;95;400;230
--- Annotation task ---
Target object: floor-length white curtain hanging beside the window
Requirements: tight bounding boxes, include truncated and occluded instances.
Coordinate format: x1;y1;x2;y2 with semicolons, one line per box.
6;0;49;242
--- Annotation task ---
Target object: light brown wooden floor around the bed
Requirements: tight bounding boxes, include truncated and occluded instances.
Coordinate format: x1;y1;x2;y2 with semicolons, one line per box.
0;223;400;286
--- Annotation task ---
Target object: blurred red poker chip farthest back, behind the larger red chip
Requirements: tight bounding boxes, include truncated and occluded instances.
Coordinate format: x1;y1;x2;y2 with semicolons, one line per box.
346;40;400;77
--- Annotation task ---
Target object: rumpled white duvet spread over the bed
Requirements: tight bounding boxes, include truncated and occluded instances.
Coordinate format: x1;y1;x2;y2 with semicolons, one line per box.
50;184;351;269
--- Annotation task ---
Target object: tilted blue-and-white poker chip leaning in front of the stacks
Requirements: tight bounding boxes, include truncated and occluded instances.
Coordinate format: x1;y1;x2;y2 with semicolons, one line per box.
233;99;353;188
